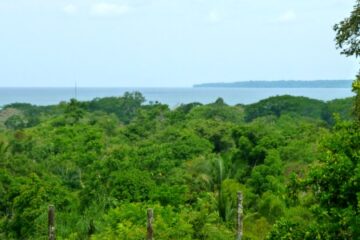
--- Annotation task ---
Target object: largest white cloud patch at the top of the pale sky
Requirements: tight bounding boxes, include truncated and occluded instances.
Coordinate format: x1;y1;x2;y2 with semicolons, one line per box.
90;3;130;16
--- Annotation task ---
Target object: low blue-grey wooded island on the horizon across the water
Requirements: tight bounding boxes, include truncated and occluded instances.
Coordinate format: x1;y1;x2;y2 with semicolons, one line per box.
193;80;352;88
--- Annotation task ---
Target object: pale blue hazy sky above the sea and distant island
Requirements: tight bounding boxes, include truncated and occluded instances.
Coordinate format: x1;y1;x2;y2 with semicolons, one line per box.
0;0;359;87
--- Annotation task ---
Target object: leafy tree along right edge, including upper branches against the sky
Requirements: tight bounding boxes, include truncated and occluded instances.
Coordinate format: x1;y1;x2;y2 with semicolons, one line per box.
268;3;360;239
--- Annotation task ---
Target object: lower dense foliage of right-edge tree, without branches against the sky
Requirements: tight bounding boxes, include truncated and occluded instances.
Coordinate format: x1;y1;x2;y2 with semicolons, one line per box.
270;123;360;239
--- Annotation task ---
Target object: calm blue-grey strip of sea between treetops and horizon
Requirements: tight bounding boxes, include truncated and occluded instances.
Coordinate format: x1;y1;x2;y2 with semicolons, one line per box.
0;88;353;107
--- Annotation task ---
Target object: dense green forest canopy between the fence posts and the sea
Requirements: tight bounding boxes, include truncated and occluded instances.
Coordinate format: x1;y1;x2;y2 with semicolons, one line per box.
0;92;360;239
